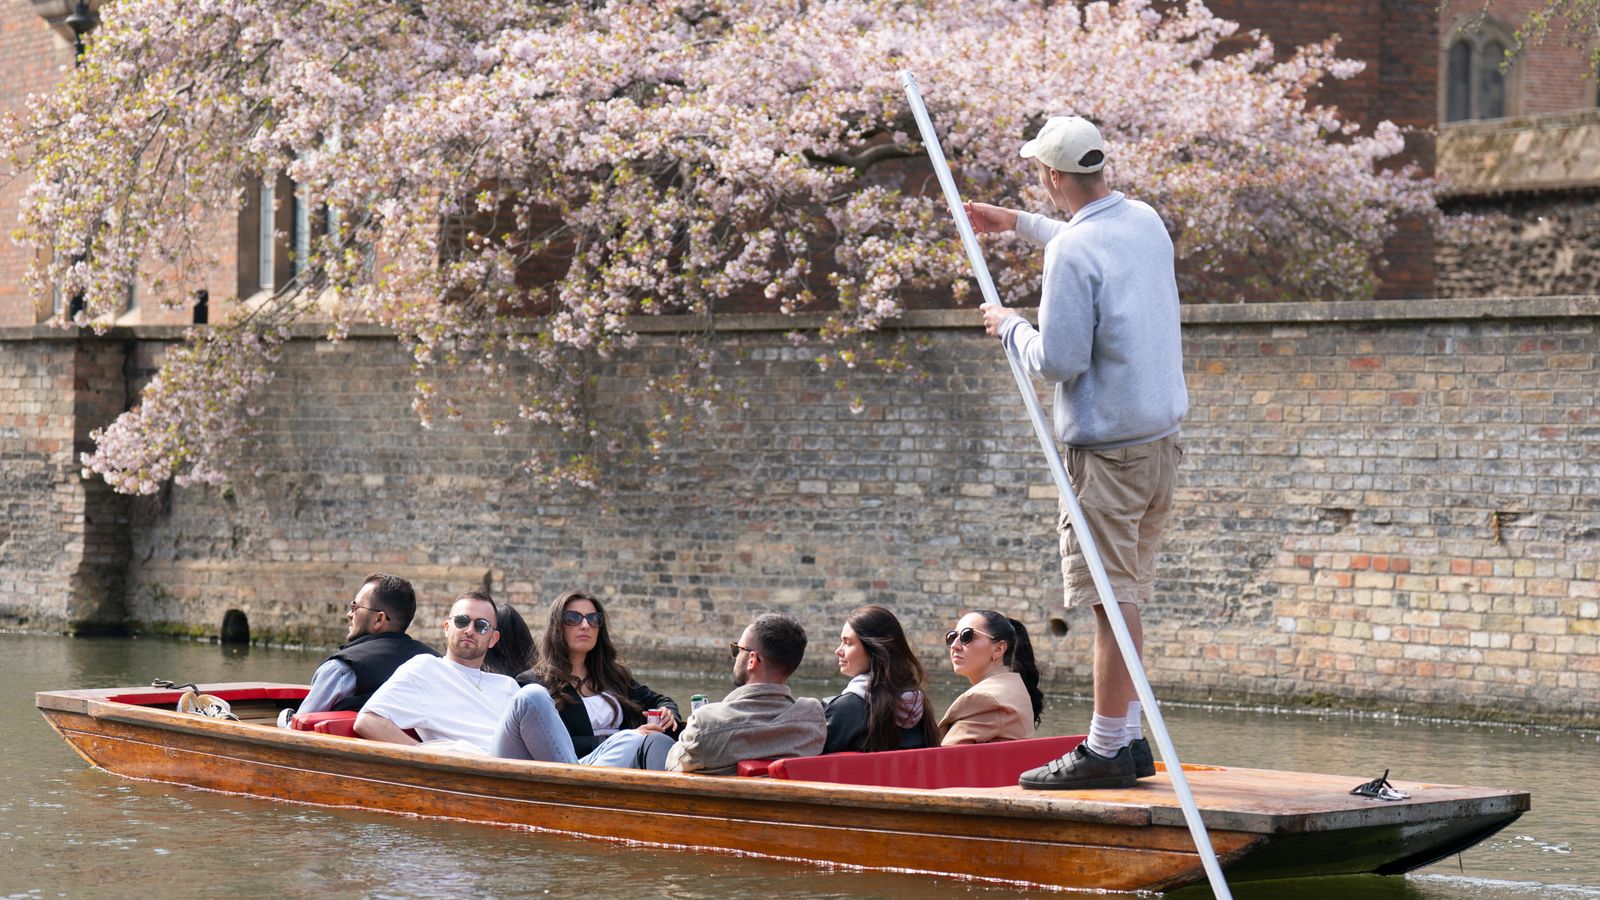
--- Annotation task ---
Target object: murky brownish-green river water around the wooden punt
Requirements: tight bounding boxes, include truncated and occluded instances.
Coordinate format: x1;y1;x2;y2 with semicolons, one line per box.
0;634;1600;900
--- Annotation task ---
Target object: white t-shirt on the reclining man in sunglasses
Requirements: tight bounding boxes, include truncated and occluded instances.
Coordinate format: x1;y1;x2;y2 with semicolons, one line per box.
362;653;518;756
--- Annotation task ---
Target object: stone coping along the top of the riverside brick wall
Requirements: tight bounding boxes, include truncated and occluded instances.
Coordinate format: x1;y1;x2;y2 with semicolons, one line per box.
0;295;1600;341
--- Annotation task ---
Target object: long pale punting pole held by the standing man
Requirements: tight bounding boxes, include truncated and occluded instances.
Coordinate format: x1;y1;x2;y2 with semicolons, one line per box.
899;70;1232;900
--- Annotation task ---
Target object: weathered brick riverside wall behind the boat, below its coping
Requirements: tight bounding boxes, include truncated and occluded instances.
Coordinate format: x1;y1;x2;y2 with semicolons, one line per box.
0;296;1600;725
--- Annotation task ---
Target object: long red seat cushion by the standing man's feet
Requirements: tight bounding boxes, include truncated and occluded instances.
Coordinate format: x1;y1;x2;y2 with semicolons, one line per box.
768;735;1083;790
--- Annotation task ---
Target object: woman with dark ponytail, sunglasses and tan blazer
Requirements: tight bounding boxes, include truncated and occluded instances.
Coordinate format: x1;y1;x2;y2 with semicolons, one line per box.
939;610;1045;746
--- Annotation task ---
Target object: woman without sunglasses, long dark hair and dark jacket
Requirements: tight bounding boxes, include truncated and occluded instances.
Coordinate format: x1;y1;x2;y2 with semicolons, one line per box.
822;607;939;753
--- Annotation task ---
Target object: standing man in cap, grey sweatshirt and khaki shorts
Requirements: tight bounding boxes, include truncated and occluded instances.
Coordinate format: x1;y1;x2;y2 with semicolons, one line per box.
966;115;1189;790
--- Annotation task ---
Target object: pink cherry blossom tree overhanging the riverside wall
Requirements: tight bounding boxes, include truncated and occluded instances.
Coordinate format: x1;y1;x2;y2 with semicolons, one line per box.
8;0;1434;493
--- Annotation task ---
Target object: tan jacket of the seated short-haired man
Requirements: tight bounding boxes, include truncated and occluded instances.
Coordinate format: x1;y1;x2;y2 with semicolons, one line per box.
667;684;827;775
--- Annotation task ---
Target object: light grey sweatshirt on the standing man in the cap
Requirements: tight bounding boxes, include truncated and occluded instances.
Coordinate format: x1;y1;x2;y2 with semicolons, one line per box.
1000;192;1189;450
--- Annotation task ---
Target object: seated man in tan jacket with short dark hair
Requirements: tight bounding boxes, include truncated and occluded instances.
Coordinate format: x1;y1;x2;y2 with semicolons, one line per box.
667;612;827;775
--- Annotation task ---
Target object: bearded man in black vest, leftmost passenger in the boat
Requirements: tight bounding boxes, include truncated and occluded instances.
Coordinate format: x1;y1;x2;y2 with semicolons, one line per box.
278;572;438;727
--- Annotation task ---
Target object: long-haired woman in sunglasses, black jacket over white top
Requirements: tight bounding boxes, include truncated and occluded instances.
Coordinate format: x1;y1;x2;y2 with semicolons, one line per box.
517;591;682;769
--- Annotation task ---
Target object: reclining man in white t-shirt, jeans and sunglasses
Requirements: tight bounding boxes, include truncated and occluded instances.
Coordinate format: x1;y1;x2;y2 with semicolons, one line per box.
355;591;672;769
